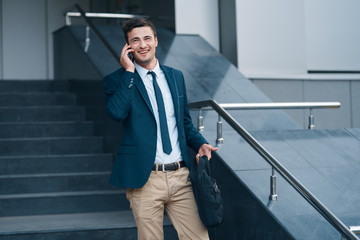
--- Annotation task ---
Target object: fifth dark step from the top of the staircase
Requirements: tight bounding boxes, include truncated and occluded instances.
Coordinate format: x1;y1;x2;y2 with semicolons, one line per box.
0;137;103;156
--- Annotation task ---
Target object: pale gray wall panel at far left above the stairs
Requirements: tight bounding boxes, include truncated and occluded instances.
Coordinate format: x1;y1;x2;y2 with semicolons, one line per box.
2;0;47;79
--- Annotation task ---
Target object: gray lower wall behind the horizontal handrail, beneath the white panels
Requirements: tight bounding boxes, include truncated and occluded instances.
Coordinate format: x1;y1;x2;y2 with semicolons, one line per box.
252;76;360;129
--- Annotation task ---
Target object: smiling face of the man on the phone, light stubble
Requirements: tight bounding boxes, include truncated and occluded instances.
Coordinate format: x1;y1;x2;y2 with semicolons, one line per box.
128;26;158;70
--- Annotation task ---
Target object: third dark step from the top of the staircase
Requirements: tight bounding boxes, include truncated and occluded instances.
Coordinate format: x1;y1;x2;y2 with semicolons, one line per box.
0;106;85;122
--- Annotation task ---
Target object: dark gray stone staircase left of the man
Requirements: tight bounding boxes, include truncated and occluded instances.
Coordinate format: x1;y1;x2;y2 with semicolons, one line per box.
0;81;174;240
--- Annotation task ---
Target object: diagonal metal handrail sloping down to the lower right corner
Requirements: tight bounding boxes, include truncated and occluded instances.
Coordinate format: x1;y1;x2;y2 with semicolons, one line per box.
189;100;359;240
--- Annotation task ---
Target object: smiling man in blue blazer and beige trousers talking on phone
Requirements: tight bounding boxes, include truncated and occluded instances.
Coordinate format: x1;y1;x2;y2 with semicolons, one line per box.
103;18;217;240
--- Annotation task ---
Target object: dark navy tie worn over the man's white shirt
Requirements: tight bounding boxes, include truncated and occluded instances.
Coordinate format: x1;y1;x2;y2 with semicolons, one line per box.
148;71;172;154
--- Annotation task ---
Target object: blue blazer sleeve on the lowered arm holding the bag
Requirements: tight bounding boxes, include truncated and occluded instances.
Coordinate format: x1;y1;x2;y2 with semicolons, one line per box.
181;73;208;153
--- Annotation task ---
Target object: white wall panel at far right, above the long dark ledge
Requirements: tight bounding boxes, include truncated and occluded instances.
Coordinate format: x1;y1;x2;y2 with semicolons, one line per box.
305;0;360;71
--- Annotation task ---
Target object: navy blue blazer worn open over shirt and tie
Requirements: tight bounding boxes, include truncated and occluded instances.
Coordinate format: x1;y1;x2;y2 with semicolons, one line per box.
103;65;207;188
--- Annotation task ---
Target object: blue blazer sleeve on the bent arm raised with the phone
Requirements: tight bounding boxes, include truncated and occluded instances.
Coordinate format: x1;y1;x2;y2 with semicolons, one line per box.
103;70;135;122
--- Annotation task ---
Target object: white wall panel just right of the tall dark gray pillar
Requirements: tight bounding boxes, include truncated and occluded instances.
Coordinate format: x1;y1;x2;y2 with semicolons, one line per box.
236;0;306;77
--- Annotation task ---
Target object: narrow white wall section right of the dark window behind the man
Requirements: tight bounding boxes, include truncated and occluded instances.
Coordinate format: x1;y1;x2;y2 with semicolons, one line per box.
175;0;220;50
